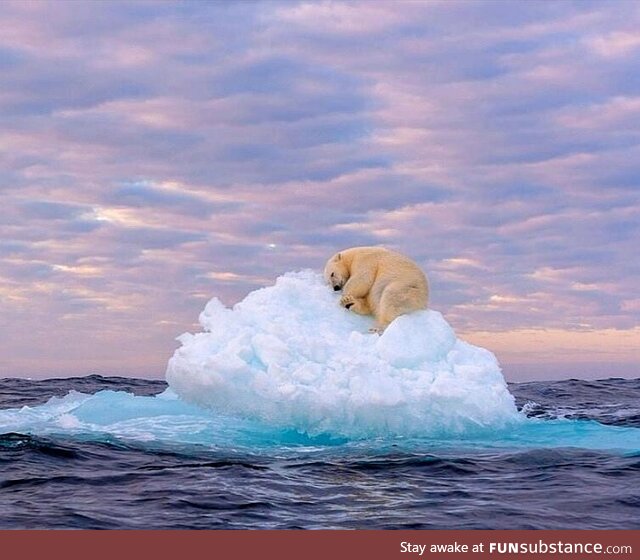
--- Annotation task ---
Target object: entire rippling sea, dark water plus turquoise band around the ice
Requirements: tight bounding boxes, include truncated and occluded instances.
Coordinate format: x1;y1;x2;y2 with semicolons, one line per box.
0;376;640;529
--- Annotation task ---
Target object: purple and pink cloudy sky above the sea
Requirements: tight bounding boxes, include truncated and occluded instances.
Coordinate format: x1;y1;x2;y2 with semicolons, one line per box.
0;0;640;381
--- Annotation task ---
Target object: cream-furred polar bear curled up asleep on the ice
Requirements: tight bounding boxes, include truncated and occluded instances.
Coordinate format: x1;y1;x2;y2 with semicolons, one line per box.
324;247;429;332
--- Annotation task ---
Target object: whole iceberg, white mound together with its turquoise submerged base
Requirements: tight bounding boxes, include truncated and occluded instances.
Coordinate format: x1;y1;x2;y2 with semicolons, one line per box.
0;270;639;457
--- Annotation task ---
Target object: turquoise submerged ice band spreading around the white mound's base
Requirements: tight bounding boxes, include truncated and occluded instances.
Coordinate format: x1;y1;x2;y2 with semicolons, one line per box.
0;389;640;457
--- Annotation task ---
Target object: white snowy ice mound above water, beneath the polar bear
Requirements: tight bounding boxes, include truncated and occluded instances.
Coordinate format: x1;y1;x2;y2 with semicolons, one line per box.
167;271;523;438
